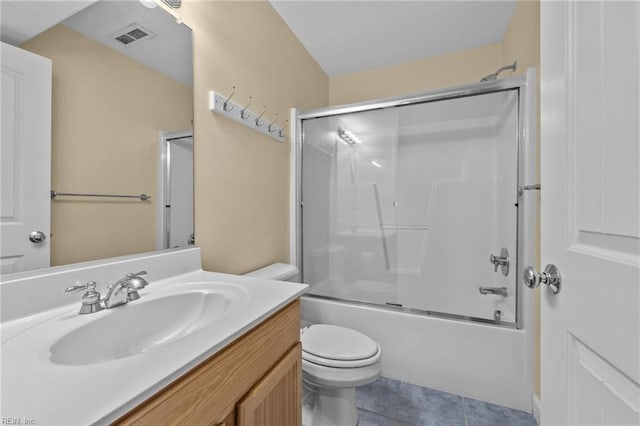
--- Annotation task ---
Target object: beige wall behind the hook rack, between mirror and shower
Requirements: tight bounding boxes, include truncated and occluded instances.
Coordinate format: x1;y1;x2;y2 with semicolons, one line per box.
172;0;329;273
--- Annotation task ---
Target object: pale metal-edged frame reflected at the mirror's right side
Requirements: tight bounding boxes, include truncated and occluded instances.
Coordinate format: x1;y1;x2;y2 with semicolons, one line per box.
156;129;193;250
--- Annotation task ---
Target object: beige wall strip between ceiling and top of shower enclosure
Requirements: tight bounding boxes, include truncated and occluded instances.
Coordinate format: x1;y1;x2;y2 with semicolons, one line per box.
329;43;502;105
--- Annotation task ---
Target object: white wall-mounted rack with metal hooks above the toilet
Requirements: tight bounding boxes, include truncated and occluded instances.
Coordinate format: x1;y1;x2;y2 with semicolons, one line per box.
209;90;286;142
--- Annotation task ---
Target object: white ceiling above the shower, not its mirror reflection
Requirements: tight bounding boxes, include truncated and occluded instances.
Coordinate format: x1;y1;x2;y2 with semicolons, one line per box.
270;0;516;77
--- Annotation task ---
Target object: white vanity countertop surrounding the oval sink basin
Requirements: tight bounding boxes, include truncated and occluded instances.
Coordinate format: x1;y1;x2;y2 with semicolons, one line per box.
0;270;307;425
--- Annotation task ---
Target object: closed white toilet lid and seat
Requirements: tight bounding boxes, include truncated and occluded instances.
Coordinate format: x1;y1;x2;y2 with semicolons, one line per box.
301;324;382;368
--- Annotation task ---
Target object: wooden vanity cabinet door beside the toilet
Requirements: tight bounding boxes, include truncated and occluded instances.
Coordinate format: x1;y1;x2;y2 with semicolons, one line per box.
236;343;302;426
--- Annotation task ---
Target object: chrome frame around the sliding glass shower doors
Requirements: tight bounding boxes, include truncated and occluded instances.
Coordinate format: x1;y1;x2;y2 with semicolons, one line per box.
291;74;536;329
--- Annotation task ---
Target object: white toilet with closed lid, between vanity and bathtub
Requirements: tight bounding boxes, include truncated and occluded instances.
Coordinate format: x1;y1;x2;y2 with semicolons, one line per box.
246;263;382;426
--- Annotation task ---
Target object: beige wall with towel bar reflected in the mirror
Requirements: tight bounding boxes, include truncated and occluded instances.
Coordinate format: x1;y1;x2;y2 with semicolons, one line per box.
21;25;193;265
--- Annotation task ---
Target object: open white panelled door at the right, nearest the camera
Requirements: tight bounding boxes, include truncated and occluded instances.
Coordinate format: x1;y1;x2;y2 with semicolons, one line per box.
540;1;640;425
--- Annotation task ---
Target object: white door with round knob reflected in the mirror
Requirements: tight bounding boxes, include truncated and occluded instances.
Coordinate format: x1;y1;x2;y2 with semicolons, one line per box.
0;43;51;274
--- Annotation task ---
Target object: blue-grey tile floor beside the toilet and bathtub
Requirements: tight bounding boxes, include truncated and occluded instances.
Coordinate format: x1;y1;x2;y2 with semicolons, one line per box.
356;377;537;426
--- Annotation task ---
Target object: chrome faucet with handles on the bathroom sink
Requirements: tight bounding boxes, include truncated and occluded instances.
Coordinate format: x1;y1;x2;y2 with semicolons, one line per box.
65;271;149;314
